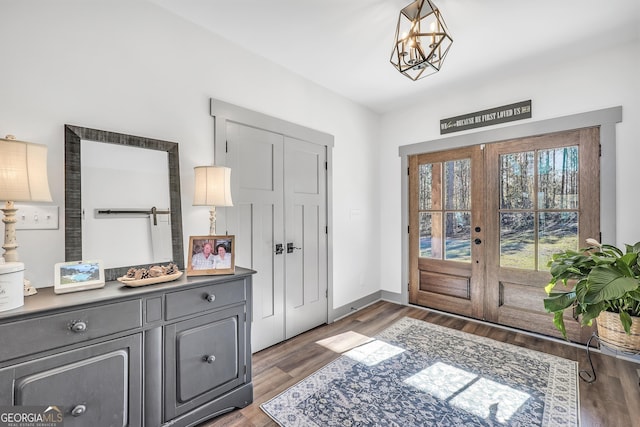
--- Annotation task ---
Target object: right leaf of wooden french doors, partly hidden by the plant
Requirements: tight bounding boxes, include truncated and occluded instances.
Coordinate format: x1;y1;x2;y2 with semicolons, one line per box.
485;128;600;342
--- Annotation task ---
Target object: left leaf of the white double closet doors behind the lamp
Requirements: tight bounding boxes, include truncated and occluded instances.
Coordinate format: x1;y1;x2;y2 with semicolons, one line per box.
227;122;285;351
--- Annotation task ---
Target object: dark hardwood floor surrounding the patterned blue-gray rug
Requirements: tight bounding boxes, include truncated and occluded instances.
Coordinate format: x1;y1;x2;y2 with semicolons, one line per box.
205;302;640;427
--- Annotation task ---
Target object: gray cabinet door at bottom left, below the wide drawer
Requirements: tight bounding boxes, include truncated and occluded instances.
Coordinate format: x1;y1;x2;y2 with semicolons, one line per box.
0;334;142;427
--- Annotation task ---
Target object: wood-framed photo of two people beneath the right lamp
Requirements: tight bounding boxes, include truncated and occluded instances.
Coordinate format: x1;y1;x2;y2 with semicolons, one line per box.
186;236;236;276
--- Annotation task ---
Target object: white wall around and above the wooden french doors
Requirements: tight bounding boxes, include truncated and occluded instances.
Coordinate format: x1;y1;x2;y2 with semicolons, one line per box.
380;37;640;292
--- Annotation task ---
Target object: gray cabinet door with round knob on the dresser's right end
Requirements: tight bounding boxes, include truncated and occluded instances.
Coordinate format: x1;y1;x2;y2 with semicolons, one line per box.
165;304;248;421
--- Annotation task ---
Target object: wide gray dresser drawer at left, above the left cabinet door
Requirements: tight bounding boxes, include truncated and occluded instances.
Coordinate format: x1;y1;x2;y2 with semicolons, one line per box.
0;300;142;360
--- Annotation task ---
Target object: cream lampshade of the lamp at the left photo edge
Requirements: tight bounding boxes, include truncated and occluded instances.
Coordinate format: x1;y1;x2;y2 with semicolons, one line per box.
0;136;51;202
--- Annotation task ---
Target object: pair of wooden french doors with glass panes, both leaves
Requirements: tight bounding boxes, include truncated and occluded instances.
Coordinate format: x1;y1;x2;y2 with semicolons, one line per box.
409;128;600;342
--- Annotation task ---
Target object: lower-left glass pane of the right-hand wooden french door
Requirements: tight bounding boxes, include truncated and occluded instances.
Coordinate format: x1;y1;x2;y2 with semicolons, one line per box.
500;212;536;270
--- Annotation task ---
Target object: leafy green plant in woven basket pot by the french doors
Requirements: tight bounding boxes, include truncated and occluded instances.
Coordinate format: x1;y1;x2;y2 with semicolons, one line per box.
544;239;640;352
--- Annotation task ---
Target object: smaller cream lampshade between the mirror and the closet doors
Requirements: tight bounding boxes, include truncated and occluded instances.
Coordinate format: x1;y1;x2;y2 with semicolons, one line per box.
193;166;233;206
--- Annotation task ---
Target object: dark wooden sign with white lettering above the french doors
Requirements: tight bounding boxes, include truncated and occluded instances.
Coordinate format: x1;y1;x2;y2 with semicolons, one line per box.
440;99;531;135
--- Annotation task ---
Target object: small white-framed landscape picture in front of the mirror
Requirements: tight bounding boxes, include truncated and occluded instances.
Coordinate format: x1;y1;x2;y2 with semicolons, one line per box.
53;260;104;294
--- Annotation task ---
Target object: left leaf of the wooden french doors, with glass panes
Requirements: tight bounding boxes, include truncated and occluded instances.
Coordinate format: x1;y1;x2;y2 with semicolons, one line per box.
409;146;484;318
